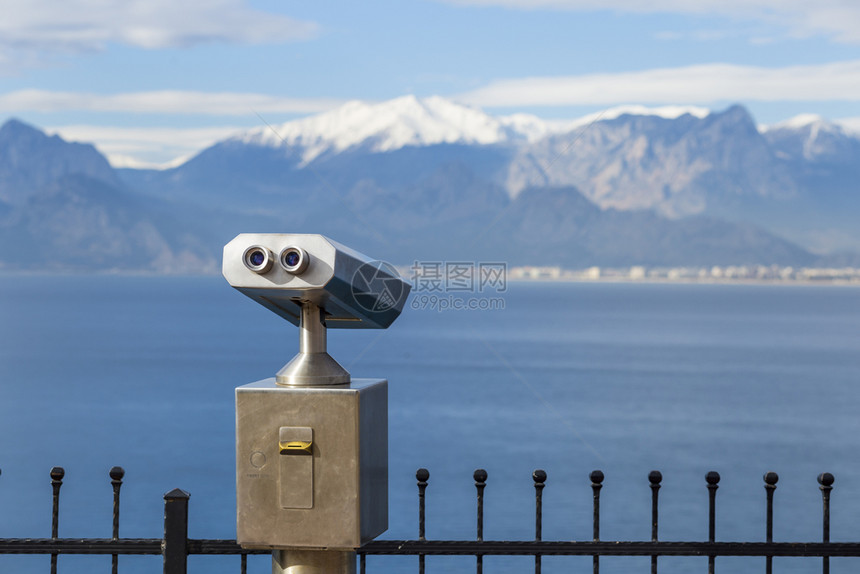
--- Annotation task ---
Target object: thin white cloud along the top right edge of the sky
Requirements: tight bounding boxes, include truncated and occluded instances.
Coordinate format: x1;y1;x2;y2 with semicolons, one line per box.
448;0;860;44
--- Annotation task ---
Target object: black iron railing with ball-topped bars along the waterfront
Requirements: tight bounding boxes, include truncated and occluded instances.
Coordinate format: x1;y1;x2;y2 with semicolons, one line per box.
0;467;860;574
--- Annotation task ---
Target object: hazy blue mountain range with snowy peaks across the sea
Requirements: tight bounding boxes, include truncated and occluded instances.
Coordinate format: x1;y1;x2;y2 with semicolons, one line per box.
0;96;860;273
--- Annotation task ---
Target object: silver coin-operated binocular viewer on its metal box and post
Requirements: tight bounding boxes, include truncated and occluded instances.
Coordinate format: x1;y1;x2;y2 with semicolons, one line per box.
222;234;409;574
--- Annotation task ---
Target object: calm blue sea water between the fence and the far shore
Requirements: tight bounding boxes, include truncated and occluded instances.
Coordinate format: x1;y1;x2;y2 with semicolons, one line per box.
0;276;860;573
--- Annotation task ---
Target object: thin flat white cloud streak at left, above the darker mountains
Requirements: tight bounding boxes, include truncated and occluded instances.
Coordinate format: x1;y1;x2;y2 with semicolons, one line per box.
0;90;343;116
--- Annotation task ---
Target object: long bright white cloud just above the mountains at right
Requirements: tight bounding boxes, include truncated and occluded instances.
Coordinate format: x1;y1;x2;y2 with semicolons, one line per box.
457;60;860;108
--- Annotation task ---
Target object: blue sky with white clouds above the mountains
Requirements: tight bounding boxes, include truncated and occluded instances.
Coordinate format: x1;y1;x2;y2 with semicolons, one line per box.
0;0;860;165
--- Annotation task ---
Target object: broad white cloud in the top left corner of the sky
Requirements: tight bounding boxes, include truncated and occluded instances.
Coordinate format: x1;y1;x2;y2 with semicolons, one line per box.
0;0;317;55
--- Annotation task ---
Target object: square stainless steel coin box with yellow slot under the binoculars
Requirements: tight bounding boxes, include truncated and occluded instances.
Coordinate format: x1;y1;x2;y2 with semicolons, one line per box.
236;378;388;549
